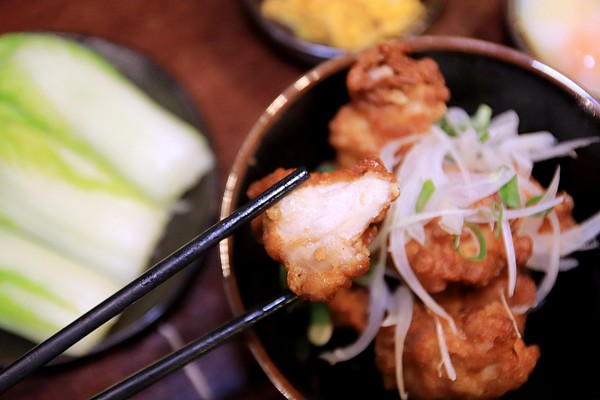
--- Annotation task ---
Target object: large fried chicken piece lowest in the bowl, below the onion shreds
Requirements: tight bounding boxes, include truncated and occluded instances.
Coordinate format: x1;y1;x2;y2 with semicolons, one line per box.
375;273;540;400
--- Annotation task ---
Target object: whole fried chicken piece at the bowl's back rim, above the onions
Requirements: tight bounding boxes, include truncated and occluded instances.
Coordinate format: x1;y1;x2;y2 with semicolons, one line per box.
329;41;450;166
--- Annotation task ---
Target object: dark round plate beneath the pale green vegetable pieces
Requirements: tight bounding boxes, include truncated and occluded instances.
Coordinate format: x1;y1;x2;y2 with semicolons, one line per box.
0;33;218;365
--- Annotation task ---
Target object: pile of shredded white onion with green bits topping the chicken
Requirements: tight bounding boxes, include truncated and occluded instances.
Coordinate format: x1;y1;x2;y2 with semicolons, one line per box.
322;106;600;399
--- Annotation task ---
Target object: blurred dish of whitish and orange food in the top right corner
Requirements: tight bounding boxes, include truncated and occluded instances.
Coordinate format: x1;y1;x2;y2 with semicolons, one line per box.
507;0;600;98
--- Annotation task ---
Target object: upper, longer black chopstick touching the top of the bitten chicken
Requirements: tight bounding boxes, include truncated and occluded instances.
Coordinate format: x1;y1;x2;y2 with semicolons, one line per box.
0;168;309;394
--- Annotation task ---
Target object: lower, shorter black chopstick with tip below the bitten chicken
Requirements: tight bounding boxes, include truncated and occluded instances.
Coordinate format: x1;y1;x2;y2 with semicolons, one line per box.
92;290;298;400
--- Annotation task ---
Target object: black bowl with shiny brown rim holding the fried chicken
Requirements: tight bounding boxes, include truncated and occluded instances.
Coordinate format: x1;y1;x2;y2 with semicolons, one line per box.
221;36;600;399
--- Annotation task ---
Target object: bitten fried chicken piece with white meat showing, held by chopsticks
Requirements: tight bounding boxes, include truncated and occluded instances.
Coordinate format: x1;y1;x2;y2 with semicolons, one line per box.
249;158;399;301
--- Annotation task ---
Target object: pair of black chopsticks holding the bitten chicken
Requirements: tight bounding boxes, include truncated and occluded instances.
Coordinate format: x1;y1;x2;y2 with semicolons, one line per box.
0;168;310;399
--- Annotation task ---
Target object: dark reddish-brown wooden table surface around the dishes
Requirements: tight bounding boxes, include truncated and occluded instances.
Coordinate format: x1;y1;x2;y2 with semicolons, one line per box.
0;0;510;400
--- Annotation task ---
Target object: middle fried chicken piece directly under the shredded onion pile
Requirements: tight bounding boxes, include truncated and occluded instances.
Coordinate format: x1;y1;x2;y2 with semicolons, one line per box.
406;220;532;293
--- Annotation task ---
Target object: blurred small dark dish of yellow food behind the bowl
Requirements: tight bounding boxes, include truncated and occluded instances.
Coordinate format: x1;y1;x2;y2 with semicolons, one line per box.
241;0;443;65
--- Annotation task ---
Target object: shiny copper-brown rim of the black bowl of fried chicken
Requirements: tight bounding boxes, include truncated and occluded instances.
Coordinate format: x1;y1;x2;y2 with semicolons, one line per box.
219;35;600;399
